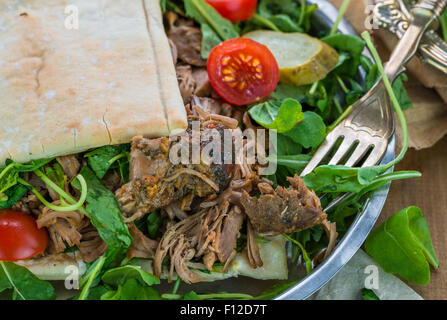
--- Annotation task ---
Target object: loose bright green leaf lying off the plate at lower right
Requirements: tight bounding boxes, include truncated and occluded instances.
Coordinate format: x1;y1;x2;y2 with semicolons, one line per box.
365;207;438;284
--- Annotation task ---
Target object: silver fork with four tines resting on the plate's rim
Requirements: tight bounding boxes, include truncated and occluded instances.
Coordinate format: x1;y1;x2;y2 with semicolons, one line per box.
301;0;447;211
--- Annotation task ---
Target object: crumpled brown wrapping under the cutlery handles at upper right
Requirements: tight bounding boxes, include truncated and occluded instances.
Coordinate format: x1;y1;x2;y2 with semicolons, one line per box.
329;0;447;150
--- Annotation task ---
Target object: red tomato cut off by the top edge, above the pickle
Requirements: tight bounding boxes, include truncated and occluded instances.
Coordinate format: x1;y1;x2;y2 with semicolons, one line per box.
206;0;258;22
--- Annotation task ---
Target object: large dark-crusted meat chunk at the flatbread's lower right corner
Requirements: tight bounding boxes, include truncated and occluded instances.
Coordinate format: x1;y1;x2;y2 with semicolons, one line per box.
115;111;237;223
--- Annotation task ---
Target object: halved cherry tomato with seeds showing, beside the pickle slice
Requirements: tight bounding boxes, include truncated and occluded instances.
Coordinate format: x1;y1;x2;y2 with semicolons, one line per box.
207;38;279;106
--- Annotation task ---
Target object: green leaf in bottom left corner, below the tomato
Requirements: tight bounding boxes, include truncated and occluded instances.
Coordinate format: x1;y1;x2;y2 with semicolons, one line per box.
0;261;56;300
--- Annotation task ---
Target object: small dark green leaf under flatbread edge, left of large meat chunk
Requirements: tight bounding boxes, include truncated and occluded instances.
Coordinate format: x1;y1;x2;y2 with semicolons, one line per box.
85;144;130;179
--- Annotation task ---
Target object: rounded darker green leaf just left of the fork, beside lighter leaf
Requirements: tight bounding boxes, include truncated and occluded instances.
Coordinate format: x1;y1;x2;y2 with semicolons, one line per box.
283;111;326;148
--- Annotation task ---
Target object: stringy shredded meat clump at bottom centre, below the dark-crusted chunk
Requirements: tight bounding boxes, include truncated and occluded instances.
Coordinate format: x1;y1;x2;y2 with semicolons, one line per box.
154;191;244;283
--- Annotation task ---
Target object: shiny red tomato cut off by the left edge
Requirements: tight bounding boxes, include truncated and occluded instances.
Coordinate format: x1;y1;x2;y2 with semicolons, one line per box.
0;210;48;261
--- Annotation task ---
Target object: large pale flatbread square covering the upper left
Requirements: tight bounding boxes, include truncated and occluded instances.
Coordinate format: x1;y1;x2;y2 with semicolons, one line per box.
0;0;187;165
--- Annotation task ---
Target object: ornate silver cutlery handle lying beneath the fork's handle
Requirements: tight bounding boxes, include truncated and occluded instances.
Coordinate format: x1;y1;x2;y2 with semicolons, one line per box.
374;0;447;73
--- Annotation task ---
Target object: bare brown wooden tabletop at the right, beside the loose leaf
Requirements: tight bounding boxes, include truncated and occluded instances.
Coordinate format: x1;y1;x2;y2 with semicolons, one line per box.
378;136;447;300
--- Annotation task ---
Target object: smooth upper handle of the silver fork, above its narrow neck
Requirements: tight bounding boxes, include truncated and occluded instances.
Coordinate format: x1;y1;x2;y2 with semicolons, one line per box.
386;0;447;81
